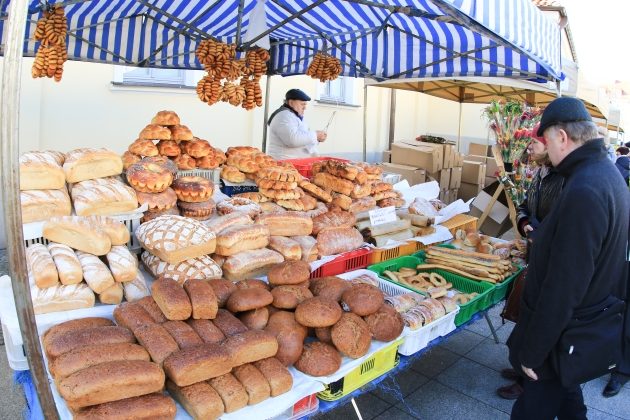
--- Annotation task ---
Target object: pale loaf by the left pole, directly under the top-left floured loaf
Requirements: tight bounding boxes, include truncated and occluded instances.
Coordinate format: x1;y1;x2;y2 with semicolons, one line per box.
20;186;72;223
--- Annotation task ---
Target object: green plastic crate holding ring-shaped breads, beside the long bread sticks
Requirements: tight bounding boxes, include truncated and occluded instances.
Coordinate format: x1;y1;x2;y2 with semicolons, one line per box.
368;256;494;326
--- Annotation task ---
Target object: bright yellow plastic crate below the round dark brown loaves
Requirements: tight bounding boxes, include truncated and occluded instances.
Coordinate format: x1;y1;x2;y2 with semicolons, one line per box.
317;338;404;401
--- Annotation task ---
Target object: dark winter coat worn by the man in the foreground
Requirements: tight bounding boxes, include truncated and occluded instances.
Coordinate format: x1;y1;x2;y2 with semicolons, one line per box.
508;139;630;379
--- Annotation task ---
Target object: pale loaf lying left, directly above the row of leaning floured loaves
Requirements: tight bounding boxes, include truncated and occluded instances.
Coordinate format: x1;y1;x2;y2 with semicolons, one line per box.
42;216;112;256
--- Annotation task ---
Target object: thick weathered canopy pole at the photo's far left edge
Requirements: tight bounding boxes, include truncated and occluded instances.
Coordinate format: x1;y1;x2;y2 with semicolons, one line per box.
0;0;58;419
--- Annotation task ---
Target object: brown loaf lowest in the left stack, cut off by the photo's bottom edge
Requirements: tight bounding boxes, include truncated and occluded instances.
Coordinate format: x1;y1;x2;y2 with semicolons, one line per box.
74;393;177;420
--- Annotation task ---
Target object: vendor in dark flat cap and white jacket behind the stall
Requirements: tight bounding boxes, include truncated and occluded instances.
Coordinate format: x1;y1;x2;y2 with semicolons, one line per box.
267;89;326;159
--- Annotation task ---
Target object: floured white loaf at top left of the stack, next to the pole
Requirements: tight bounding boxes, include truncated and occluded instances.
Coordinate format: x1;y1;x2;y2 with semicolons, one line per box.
20;152;66;191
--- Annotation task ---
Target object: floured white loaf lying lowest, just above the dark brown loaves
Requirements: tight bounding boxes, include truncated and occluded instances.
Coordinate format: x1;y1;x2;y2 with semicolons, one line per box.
31;283;94;314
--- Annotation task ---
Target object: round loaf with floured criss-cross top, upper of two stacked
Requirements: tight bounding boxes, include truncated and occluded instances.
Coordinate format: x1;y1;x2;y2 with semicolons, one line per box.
135;216;216;264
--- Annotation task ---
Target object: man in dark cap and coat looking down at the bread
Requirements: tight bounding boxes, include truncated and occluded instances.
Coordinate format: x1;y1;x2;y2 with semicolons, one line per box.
508;98;630;419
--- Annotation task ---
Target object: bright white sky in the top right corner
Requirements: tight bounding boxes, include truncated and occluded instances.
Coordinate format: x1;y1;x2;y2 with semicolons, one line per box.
559;0;630;84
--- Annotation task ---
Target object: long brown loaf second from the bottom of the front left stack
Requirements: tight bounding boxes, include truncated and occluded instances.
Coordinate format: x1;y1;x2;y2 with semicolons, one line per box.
58;360;165;409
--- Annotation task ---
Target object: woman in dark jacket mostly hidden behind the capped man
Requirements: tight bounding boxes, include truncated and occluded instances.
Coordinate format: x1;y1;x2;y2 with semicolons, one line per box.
497;124;564;400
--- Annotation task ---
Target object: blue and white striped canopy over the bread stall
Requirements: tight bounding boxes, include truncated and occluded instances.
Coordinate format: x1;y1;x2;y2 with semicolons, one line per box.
0;0;562;80
